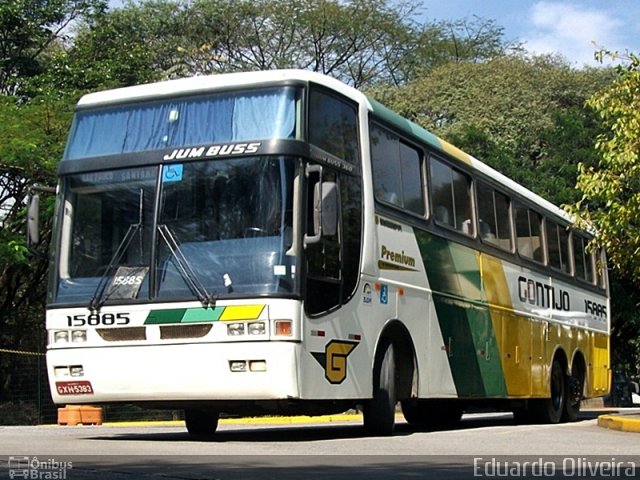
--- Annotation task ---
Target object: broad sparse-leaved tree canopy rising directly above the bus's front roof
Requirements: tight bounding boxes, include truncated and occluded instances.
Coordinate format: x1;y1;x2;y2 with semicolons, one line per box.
61;0;514;88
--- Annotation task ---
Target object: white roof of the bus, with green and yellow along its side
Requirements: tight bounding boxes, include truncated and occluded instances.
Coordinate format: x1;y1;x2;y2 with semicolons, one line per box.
77;69;572;222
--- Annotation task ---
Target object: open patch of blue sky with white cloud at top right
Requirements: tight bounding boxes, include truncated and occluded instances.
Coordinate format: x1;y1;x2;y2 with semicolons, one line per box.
422;0;640;68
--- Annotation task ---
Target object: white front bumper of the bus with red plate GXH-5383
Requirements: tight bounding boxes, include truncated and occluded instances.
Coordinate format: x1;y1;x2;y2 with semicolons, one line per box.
47;342;300;405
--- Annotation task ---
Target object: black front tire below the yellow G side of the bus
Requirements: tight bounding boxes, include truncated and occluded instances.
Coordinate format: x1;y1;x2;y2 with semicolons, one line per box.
362;341;396;437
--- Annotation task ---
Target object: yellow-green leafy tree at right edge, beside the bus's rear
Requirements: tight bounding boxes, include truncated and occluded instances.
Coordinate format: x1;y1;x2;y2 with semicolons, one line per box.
571;52;640;375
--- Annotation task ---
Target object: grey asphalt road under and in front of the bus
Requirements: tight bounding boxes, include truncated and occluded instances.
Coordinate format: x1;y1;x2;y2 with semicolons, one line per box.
0;413;640;480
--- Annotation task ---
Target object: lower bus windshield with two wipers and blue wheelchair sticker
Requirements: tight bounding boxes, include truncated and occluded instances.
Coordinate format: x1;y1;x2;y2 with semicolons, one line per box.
52;156;296;307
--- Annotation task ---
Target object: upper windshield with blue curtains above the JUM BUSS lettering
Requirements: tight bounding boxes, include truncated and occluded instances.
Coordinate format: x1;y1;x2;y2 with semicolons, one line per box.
63;87;298;161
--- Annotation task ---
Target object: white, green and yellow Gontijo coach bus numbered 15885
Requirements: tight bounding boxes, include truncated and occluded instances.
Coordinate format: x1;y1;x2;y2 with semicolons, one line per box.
31;70;610;435
